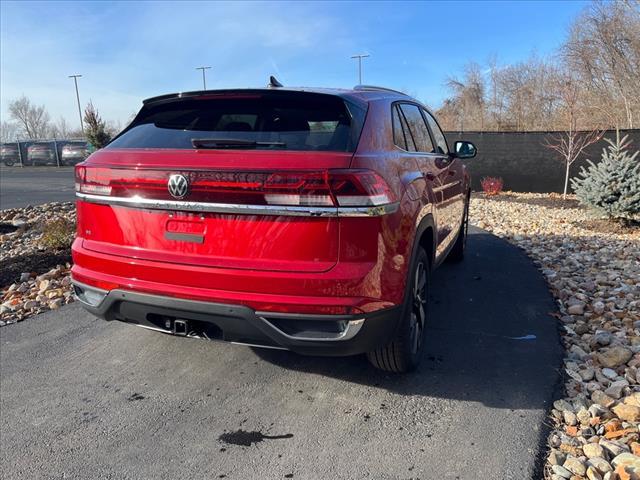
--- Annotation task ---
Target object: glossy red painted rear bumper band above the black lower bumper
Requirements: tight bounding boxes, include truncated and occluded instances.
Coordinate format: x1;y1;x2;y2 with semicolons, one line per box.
71;237;400;315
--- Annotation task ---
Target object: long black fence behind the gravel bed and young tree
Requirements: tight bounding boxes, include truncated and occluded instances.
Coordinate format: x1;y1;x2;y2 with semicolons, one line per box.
445;129;640;193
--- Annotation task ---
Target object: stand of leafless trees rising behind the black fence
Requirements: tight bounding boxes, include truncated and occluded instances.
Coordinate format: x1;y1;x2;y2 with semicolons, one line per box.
438;0;640;131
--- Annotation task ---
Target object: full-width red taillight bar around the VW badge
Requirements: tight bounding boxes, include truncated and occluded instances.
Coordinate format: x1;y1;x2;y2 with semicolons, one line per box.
76;166;395;207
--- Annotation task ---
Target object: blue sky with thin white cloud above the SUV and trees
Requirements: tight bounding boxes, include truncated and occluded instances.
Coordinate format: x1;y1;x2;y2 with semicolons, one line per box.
0;1;586;125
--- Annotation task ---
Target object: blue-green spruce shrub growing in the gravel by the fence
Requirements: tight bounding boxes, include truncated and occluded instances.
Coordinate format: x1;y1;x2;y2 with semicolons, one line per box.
571;133;640;220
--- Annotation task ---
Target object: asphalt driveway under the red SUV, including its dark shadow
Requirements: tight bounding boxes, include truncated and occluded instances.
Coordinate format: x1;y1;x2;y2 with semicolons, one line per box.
0;229;561;480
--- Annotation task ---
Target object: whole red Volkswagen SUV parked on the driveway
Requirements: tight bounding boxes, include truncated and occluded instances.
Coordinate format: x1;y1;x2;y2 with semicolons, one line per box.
72;84;475;372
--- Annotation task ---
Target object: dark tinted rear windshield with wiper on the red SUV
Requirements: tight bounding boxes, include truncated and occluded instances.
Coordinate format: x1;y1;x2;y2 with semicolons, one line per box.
107;92;366;152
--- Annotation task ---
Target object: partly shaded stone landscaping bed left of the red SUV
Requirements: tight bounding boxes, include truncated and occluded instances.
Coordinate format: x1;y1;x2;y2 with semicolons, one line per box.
0;202;75;326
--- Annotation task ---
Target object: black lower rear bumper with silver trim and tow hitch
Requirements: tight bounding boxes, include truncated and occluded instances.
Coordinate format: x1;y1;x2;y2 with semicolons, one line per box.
74;281;399;356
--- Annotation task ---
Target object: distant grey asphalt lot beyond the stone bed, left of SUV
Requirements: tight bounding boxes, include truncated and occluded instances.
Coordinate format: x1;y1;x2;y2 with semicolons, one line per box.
0;165;75;209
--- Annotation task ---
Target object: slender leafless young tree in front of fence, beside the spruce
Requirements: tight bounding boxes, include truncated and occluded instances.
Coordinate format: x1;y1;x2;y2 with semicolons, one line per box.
545;75;603;199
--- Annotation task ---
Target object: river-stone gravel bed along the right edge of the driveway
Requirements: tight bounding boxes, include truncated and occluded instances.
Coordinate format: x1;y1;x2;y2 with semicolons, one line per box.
470;193;640;480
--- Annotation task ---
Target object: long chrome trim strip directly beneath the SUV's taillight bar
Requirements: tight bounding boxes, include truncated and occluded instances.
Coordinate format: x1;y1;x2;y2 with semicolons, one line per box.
76;192;399;217
